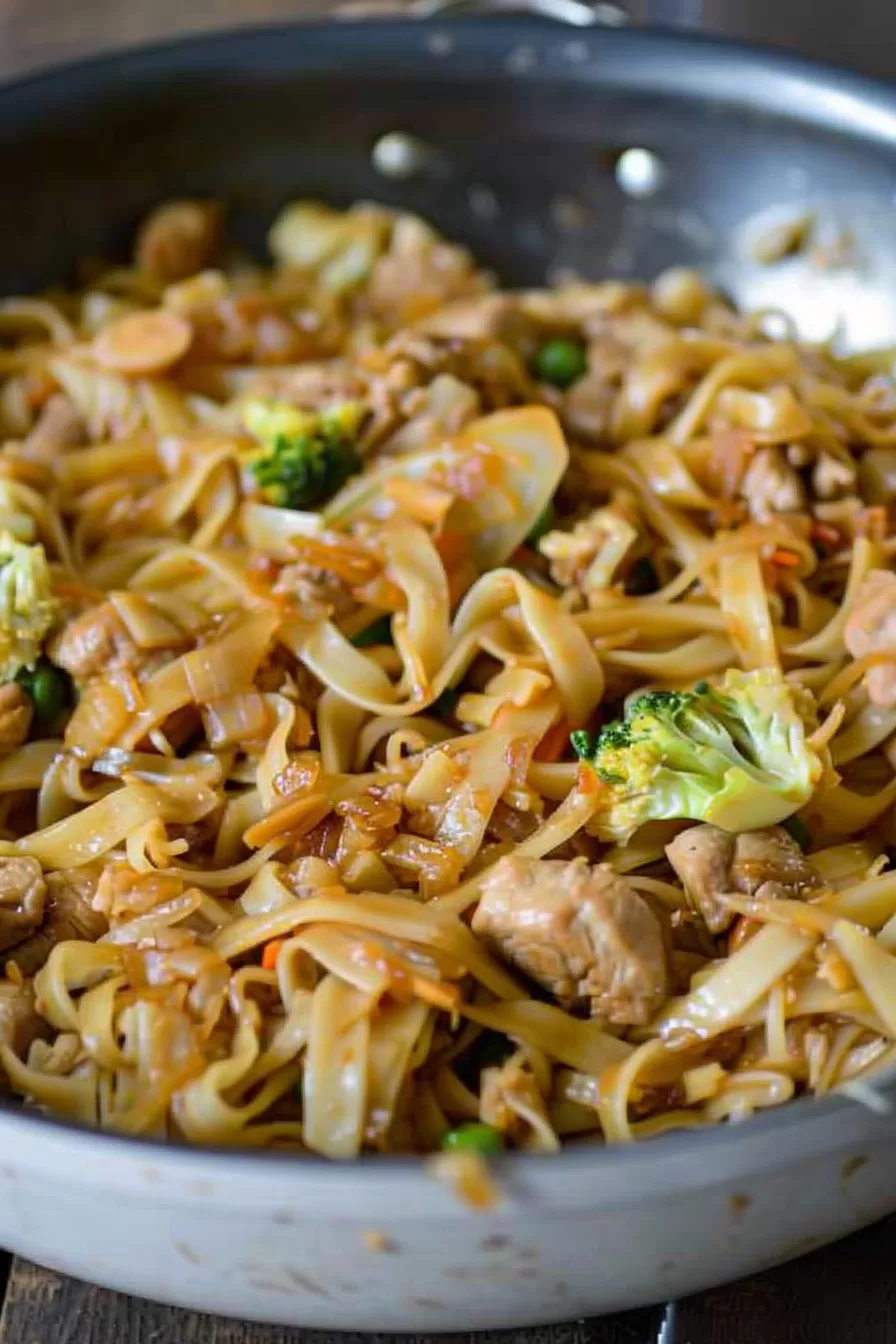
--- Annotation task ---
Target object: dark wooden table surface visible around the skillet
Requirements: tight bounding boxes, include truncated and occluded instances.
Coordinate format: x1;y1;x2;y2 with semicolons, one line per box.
0;0;896;1344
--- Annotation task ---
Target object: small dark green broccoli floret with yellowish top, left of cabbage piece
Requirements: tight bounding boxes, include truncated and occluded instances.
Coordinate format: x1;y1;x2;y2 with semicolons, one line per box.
243;402;363;509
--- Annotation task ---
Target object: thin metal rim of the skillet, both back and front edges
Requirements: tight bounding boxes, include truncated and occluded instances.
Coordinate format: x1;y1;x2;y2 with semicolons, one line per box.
0;16;896;1177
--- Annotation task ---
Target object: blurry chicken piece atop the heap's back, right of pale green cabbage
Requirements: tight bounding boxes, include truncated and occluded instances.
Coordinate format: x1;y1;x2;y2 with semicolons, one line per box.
367;215;486;329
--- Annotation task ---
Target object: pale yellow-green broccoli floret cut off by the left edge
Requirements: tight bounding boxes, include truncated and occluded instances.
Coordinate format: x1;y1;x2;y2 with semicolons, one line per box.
0;532;56;685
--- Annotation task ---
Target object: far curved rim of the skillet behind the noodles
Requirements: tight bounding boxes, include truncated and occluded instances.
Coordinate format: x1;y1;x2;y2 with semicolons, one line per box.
0;15;896;148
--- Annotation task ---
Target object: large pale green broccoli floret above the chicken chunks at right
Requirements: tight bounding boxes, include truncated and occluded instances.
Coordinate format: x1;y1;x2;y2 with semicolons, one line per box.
571;671;823;841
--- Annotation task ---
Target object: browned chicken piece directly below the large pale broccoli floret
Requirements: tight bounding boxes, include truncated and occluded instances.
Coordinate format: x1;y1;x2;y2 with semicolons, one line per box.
666;825;822;933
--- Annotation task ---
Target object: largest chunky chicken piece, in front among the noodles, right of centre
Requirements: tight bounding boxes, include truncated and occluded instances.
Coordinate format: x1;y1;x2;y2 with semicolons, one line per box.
473;856;668;1025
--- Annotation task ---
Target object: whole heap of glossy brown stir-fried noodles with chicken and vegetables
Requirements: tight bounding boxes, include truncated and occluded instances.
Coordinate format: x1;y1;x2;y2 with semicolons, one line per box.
0;202;896;1157
